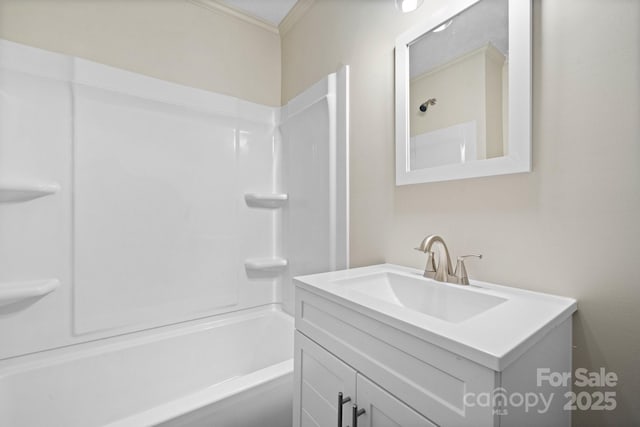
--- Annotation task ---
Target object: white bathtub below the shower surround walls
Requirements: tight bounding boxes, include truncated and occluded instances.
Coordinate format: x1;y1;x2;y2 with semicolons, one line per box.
0;308;293;427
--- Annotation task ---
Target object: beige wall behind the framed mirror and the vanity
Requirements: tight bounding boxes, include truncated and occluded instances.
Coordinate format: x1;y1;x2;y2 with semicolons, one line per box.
282;0;640;426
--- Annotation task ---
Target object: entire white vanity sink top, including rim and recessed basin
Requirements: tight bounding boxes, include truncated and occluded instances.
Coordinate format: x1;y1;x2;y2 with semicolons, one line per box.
294;264;577;371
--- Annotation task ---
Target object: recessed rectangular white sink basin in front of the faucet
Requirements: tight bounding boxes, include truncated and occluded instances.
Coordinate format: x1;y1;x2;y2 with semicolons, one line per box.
334;273;506;323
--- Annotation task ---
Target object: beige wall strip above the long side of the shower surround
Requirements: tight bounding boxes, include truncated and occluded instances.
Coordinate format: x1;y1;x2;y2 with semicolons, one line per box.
0;0;281;106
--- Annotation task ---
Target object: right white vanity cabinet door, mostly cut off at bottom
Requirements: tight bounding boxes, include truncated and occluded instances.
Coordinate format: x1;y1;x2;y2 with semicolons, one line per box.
356;375;436;427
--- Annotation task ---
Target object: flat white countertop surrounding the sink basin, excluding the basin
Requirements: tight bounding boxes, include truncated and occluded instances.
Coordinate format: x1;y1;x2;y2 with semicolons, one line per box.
294;264;577;371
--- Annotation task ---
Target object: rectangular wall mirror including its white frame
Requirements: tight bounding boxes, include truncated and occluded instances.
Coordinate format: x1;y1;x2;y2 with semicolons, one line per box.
396;0;531;185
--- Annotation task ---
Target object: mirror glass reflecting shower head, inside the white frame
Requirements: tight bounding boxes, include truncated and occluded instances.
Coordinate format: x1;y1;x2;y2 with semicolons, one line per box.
408;0;509;170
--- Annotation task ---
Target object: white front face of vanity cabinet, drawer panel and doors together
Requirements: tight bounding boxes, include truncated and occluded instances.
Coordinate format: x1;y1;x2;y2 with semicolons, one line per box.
293;288;497;427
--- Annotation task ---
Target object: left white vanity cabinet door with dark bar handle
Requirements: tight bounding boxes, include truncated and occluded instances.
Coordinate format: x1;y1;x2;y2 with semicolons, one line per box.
293;331;356;427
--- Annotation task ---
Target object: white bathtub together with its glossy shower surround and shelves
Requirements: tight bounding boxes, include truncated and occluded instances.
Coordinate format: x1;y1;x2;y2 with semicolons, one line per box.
0;40;348;427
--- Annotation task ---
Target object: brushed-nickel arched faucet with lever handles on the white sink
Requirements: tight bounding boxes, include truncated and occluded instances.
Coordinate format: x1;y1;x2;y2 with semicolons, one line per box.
415;234;482;285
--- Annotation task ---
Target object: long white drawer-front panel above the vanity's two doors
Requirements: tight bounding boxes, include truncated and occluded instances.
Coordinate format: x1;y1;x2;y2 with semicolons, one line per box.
296;287;499;427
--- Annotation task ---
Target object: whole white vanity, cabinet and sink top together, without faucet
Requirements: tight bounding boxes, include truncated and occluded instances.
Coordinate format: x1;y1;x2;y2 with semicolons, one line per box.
294;264;577;427
